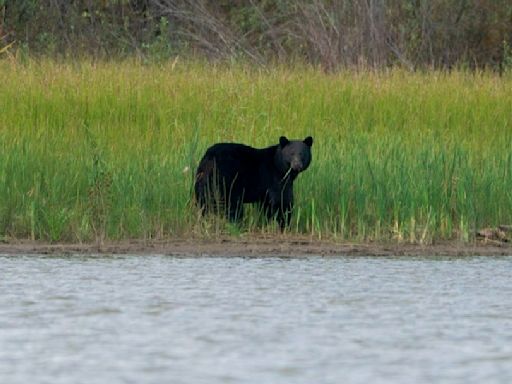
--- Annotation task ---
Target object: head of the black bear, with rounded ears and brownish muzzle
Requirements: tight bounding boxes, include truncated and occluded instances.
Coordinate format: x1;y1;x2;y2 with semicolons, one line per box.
277;136;313;175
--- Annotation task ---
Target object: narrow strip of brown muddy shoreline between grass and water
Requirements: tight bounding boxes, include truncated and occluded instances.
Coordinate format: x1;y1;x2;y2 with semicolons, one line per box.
0;236;512;257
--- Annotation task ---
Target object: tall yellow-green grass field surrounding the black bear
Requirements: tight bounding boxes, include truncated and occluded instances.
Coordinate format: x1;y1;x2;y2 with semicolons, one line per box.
0;60;512;243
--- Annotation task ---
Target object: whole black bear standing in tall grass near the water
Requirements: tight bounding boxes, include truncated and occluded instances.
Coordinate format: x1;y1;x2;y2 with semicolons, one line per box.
195;136;313;229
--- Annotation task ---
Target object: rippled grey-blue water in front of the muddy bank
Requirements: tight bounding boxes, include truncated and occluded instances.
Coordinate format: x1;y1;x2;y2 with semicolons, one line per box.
0;256;512;384
